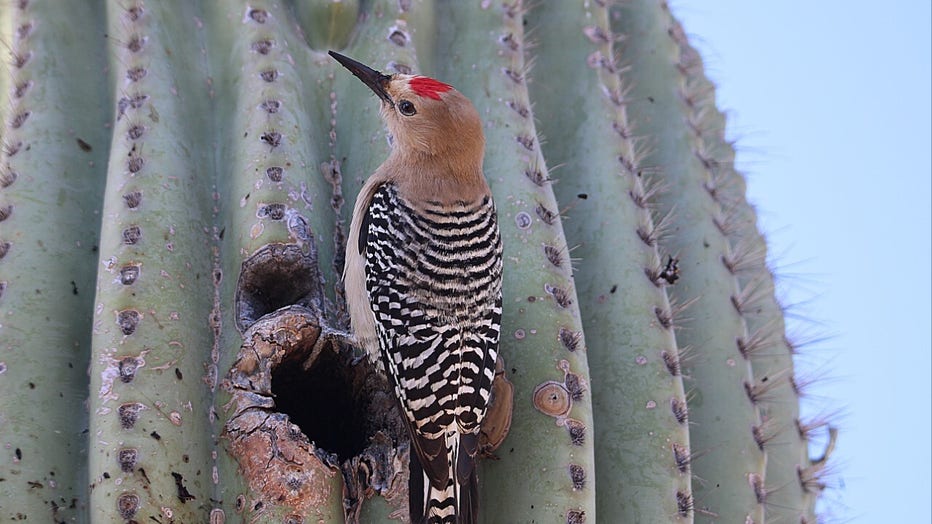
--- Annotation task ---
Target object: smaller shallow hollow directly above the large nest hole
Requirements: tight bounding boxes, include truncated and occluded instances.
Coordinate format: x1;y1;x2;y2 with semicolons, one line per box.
236;242;322;331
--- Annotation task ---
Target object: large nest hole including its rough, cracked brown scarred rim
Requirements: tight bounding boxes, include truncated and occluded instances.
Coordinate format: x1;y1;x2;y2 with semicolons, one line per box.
224;306;408;505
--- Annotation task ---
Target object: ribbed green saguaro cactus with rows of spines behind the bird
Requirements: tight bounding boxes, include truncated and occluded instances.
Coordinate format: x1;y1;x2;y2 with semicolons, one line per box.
0;0;834;523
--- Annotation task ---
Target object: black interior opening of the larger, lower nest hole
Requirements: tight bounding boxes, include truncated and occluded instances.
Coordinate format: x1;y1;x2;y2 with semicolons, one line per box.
272;350;371;462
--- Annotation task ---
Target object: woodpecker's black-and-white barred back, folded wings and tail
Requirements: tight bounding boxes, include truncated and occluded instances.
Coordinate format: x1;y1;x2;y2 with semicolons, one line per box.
359;182;502;523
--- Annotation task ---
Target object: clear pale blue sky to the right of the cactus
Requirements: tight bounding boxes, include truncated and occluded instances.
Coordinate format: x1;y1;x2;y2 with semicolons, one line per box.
671;0;932;523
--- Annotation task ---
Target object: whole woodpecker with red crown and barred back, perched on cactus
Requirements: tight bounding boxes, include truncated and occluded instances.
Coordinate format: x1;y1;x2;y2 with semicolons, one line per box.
330;51;502;524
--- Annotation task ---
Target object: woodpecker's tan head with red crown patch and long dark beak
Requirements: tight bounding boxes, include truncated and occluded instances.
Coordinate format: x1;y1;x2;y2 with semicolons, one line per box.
330;51;485;172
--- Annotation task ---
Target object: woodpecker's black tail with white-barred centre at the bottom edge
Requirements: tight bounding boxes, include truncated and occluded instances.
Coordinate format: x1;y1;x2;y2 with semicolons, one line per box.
408;436;479;524
